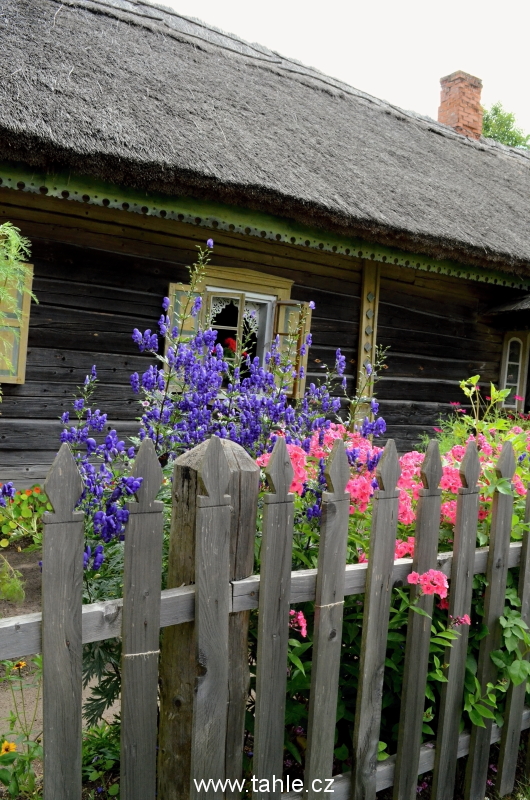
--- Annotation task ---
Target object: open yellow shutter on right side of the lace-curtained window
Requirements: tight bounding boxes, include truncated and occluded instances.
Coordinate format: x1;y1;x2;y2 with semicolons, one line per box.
273;300;311;399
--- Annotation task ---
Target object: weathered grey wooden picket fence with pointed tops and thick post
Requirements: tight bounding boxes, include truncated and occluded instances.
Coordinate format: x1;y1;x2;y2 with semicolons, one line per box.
0;437;530;800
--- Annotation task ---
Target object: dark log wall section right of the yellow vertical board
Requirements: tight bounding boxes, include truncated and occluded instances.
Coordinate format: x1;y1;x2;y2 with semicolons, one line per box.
375;265;514;451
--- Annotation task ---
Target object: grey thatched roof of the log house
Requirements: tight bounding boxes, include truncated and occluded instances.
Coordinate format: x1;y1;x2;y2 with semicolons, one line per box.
0;0;530;272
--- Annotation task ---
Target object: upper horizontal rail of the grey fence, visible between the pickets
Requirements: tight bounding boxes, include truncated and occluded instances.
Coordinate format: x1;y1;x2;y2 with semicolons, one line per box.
0;542;522;659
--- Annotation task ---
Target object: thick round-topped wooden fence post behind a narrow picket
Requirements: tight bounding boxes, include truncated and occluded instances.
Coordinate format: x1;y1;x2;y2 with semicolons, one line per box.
158;439;259;800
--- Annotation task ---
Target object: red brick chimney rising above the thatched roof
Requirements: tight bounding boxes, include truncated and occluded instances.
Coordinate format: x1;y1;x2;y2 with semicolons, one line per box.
438;70;482;139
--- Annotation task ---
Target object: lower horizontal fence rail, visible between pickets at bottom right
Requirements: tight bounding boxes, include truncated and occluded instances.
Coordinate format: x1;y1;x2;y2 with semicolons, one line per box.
281;708;530;800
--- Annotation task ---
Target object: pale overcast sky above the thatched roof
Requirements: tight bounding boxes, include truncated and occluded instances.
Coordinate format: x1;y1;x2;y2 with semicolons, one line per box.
158;0;530;133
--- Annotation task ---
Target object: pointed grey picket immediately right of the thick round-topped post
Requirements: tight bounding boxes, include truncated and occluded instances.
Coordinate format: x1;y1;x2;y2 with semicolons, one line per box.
253;437;294;800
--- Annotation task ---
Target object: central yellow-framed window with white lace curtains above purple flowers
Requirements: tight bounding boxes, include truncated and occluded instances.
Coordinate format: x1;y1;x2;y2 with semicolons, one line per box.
169;266;311;397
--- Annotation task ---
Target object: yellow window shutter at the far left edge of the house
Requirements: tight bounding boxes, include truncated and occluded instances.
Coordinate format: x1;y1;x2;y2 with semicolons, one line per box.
0;264;33;384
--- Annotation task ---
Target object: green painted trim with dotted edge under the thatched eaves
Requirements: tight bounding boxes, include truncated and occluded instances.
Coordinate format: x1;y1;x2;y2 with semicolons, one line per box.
0;162;530;289
